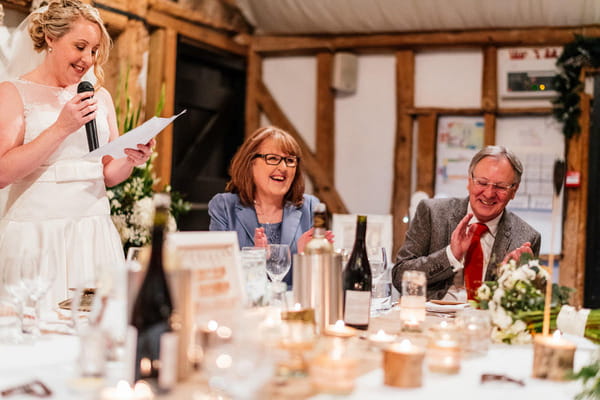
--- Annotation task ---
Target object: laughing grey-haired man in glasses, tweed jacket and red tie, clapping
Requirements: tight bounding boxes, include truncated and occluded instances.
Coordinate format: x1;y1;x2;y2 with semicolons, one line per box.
392;146;541;301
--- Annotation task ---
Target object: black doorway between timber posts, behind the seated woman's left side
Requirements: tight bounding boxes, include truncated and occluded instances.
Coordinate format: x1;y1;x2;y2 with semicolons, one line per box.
171;40;246;230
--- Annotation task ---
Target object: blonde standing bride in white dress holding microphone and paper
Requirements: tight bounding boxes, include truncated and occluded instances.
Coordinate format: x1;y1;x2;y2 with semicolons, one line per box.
0;0;153;301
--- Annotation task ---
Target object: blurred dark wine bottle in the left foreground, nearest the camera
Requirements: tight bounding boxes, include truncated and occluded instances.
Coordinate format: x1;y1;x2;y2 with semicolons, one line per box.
131;193;173;380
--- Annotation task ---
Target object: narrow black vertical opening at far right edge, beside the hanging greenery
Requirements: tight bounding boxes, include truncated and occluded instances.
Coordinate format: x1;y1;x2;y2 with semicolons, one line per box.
583;75;600;308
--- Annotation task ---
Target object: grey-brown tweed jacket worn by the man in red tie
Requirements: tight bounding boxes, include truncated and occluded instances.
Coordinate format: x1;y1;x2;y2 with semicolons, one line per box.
392;198;541;299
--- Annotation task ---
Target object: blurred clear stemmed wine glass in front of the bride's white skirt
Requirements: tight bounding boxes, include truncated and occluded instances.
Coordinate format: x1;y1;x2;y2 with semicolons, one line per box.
19;254;57;337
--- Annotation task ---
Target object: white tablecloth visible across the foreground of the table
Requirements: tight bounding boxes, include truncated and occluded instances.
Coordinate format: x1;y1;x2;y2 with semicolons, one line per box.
0;335;597;400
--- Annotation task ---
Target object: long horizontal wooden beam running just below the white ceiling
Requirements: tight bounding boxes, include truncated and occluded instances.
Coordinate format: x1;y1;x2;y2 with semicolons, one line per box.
252;25;600;53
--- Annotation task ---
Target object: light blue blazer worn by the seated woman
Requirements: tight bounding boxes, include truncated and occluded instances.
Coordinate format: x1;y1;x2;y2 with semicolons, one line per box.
208;193;319;288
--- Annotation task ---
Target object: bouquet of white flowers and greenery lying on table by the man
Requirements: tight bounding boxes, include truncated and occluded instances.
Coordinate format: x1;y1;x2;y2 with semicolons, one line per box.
473;255;600;344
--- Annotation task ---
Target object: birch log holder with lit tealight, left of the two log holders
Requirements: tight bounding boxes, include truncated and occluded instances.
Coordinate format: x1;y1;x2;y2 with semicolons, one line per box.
383;339;425;388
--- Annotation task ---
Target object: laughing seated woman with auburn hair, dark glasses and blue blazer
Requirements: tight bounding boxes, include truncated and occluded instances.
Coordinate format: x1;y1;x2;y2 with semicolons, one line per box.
208;127;333;286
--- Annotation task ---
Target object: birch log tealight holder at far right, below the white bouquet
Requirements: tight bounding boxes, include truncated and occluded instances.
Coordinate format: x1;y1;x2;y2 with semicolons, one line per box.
532;330;576;381
